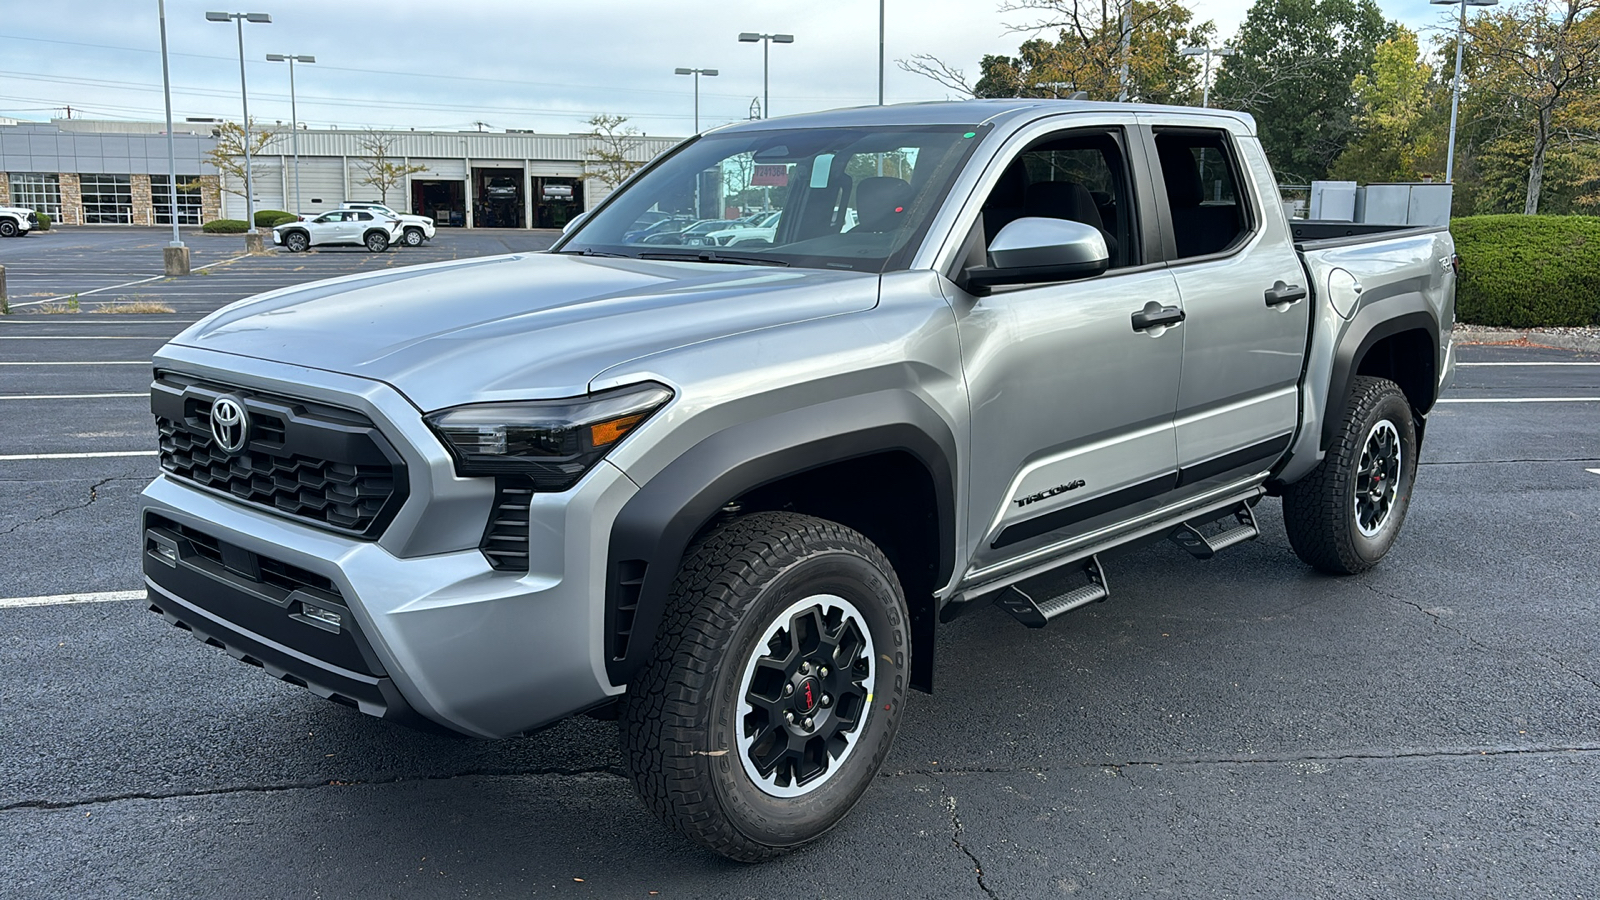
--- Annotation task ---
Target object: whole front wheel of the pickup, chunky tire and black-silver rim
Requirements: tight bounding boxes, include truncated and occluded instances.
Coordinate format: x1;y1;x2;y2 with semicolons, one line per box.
621;512;910;862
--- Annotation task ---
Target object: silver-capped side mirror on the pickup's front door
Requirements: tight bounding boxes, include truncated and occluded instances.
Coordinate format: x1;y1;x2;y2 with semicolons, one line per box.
962;218;1110;295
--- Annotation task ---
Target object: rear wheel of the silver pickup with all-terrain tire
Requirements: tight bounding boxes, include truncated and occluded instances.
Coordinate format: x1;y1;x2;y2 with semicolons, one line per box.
1283;375;1418;575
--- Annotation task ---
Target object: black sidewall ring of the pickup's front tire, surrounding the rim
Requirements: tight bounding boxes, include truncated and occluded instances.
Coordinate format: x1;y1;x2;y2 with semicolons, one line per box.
699;551;910;847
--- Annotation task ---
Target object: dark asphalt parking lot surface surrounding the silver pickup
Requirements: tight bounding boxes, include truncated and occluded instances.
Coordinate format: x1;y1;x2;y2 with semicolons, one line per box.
0;229;1600;898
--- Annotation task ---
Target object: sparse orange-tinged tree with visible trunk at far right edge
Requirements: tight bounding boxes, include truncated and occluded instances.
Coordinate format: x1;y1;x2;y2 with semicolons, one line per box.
1467;0;1600;216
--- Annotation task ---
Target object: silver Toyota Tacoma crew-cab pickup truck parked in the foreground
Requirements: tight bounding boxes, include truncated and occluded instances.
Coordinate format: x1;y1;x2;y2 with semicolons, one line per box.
139;101;1458;860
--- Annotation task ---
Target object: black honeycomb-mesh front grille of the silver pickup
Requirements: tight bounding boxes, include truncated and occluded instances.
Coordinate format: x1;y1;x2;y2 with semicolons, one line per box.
150;372;406;538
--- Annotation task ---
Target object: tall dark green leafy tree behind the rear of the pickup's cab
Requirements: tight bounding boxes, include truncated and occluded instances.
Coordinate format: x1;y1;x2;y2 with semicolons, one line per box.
1211;0;1394;184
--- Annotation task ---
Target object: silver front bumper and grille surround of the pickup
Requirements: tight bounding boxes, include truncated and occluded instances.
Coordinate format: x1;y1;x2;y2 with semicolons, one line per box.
139;348;637;738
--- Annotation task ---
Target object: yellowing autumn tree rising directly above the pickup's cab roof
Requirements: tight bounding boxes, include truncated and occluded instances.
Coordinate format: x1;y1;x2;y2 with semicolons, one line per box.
896;0;1216;102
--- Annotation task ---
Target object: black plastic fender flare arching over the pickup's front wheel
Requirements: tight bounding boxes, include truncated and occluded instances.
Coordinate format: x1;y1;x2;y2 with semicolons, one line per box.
605;391;957;685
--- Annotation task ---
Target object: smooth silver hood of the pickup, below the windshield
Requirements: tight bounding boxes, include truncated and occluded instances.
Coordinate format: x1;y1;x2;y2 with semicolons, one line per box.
173;253;878;410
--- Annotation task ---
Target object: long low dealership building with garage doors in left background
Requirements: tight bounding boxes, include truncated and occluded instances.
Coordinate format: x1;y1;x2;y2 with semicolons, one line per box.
0;119;680;227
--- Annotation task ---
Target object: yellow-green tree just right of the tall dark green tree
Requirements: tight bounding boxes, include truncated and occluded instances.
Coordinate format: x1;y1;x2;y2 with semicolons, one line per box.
1330;27;1450;183
